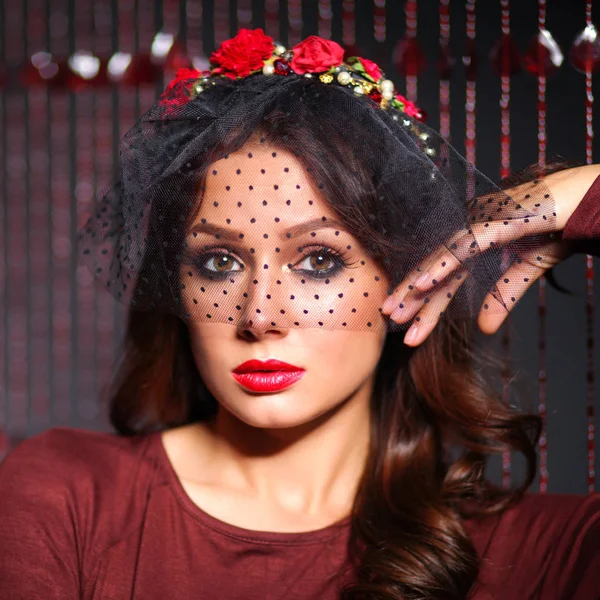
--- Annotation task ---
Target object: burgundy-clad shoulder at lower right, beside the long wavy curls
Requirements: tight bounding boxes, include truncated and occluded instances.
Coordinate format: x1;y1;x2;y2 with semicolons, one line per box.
467;493;600;599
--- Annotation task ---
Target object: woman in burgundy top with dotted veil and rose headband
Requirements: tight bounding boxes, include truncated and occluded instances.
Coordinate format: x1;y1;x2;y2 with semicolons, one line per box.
0;29;600;600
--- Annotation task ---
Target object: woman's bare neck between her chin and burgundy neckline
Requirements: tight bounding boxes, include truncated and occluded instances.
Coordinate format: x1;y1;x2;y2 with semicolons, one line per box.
199;379;372;517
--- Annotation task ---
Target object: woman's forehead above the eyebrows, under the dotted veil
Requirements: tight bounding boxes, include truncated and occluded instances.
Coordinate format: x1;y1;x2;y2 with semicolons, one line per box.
196;142;337;228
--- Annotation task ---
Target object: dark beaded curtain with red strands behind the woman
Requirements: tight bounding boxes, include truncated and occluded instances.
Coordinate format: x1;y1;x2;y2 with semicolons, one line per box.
0;0;600;493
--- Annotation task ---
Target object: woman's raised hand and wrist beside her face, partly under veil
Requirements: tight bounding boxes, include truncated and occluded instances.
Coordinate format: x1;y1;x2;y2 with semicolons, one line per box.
382;165;600;346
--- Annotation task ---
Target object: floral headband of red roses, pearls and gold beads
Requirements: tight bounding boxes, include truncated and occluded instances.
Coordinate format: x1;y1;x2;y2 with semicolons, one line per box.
160;29;426;121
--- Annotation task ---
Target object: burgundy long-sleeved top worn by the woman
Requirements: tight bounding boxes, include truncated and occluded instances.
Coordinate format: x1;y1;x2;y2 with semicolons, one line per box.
0;177;600;600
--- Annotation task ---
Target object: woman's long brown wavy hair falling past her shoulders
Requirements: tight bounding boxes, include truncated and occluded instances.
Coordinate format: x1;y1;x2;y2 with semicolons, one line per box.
109;111;564;600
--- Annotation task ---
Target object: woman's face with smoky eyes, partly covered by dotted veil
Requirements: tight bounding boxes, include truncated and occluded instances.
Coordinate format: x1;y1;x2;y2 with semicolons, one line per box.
180;142;388;428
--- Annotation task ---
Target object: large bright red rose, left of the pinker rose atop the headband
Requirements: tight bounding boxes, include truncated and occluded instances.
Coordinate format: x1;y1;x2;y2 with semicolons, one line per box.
210;29;273;79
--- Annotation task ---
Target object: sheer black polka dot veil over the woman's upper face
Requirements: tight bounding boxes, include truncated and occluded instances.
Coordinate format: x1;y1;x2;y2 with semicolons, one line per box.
78;73;556;331
